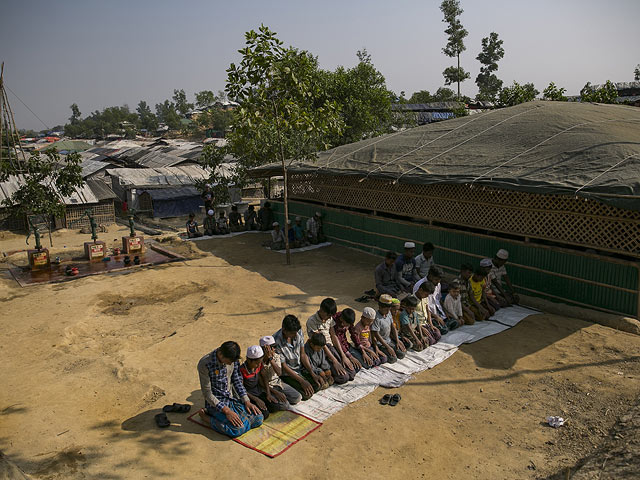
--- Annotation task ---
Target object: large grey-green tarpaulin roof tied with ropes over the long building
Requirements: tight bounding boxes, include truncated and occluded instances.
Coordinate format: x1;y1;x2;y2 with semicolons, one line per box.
250;101;640;210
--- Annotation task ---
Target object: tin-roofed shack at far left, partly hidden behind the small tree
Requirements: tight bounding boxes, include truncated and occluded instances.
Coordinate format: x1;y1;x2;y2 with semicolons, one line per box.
0;176;116;231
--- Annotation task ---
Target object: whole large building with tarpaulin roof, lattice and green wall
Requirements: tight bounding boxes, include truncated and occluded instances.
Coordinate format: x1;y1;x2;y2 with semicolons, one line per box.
253;101;640;316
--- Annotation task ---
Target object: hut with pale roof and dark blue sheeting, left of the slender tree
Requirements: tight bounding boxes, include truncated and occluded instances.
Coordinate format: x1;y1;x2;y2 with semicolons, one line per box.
107;165;209;216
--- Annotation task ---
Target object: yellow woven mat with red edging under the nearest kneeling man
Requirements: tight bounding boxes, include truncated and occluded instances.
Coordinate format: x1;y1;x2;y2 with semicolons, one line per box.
188;409;322;458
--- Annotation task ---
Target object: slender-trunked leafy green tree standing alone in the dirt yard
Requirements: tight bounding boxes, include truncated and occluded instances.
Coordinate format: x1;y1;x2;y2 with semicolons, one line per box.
219;25;344;264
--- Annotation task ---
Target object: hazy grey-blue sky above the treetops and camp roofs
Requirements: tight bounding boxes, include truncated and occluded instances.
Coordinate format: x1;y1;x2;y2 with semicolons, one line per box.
0;0;640;131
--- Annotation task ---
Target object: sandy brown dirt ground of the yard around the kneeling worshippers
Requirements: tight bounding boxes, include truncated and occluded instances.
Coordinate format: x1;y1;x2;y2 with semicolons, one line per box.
0;227;640;479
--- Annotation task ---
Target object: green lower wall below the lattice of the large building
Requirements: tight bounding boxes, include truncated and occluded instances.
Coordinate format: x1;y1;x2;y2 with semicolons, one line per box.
272;202;640;316
